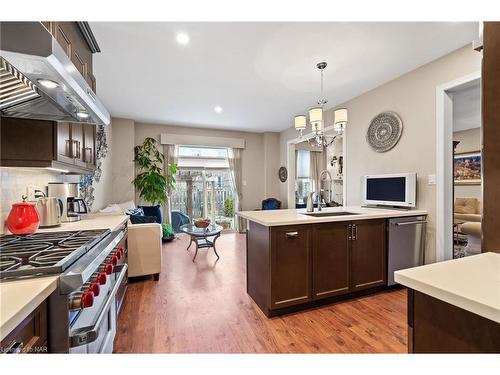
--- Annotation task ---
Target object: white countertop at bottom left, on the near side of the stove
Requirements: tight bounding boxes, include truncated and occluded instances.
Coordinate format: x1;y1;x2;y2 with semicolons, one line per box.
0;276;58;340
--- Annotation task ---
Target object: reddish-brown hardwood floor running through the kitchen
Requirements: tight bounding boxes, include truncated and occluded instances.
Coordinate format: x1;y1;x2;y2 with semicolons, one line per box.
115;233;407;353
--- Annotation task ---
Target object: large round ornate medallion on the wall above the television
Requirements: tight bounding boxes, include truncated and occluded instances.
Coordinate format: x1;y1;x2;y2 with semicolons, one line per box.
366;112;403;152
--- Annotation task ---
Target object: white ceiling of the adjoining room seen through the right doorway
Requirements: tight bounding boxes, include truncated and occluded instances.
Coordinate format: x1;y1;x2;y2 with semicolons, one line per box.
453;81;481;131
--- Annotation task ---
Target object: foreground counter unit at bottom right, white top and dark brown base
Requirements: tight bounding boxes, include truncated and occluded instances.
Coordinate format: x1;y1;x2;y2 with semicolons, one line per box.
395;252;500;353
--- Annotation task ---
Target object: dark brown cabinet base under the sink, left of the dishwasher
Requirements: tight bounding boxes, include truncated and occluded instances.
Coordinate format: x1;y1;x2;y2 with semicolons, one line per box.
247;219;387;316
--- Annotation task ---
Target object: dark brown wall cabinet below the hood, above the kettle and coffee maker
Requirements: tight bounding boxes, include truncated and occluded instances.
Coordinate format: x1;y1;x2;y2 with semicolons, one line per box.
0;117;95;174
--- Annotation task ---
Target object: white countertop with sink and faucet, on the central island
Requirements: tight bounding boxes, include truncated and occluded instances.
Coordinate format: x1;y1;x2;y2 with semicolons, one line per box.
236;206;427;227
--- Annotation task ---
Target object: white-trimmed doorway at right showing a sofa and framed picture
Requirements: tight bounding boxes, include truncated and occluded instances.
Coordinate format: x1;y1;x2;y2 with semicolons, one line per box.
436;72;482;261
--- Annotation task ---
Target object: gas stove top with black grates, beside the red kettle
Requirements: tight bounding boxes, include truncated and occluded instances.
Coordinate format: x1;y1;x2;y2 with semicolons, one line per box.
0;229;110;281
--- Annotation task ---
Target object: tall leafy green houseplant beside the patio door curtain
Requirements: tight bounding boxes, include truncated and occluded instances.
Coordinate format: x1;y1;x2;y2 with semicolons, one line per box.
132;137;177;241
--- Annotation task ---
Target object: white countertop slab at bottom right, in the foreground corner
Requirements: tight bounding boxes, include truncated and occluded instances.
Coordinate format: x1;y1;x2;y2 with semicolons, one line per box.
394;253;500;323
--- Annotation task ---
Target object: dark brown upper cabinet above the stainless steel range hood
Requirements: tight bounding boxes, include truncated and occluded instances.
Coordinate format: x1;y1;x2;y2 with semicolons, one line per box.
42;21;96;92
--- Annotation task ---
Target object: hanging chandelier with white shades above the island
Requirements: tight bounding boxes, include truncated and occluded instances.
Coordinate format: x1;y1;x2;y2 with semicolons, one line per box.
295;61;347;147
